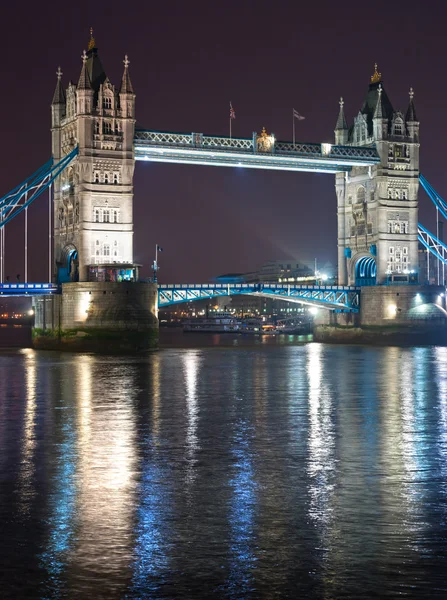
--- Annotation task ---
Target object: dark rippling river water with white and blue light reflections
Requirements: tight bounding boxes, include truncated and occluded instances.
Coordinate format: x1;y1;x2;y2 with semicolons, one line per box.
0;337;447;599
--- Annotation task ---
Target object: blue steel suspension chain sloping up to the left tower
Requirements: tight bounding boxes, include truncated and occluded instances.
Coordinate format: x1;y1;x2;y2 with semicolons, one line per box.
0;147;78;227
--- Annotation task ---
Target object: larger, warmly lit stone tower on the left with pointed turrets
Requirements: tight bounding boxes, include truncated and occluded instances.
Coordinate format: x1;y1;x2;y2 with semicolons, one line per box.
51;31;136;283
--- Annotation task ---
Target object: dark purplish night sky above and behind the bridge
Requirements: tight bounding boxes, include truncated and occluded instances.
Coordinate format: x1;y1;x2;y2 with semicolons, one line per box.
0;0;447;282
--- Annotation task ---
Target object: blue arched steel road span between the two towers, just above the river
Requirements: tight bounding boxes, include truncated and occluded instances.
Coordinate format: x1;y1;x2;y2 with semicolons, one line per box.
158;283;360;312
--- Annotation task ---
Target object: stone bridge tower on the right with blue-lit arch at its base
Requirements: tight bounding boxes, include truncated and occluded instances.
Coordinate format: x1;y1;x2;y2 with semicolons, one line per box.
335;65;419;285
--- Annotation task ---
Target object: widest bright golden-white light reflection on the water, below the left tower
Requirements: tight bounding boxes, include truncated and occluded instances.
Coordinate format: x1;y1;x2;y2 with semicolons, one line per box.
72;356;137;594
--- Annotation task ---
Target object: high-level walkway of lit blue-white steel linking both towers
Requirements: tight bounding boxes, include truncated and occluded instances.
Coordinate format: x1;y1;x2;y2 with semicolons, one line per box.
134;130;380;173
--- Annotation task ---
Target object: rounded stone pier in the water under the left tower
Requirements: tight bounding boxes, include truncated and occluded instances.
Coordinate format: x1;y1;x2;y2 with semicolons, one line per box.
33;282;158;353
